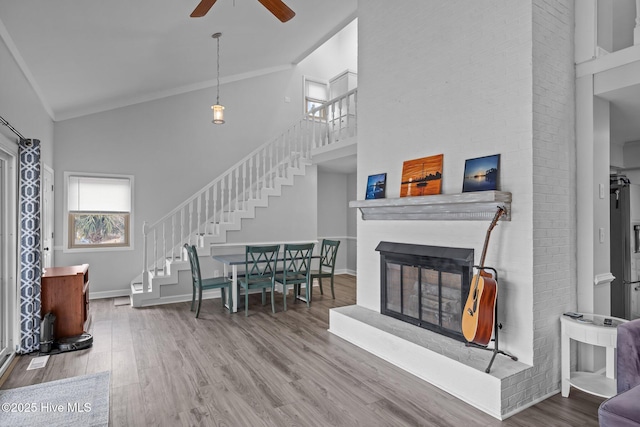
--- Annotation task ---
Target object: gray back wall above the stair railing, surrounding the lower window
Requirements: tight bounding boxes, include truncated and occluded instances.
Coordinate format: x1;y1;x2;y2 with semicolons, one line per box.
53;20;357;296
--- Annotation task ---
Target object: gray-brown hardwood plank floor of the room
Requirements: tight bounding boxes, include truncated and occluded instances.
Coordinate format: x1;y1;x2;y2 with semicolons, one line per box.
2;275;603;427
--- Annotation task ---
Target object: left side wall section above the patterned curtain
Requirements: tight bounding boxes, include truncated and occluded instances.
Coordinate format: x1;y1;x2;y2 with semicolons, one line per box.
0;35;54;166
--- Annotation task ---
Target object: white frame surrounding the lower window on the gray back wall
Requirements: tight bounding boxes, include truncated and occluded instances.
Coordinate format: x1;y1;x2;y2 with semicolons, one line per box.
62;171;135;253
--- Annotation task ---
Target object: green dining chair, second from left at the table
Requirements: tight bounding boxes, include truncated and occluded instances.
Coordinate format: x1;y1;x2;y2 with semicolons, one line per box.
238;245;280;316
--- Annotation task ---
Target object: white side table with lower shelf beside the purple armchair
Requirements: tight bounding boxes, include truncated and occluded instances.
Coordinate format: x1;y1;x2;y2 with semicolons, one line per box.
560;313;626;398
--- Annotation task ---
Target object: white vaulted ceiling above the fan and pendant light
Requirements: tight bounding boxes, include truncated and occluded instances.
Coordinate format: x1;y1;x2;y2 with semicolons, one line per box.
0;0;357;120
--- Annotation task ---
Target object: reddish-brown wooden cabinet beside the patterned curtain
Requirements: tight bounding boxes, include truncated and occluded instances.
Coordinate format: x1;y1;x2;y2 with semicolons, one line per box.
41;264;90;339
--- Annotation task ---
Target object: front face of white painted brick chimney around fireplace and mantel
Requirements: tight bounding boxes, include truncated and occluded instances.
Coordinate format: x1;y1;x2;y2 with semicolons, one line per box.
358;1;533;363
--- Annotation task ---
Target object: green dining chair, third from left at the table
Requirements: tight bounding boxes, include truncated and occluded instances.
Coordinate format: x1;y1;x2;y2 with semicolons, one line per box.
276;243;315;311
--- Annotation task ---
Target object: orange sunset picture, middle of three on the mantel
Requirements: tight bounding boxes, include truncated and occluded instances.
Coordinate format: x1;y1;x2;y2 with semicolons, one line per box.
400;154;444;197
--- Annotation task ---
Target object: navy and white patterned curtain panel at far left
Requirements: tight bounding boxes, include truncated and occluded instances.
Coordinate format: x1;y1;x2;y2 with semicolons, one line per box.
18;139;41;354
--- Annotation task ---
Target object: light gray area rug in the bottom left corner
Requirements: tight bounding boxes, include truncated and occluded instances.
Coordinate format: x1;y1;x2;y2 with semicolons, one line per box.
0;372;109;427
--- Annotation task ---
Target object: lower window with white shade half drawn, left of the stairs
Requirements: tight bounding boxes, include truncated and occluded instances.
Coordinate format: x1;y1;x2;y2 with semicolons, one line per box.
65;172;133;249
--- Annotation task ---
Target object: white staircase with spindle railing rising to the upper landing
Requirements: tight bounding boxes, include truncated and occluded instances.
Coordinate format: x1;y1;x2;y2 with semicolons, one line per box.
131;89;357;307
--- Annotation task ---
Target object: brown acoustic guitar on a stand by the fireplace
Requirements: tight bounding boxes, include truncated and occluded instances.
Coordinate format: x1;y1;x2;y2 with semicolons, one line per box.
462;206;505;346
